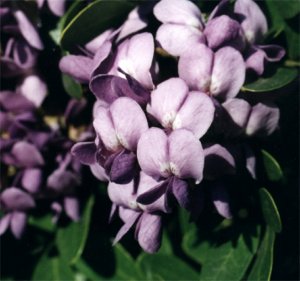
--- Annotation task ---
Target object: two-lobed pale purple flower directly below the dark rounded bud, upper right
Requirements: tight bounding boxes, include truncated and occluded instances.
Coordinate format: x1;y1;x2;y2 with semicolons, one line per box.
178;44;245;100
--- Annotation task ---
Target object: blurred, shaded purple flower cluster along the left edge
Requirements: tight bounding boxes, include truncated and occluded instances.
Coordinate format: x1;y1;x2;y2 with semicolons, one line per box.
0;1;89;239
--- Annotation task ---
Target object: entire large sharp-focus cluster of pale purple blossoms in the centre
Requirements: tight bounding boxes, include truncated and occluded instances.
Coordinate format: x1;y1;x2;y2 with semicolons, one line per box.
60;0;285;253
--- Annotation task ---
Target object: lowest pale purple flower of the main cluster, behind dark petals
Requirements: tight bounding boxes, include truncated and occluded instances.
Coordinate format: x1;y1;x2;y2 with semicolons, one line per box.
108;172;167;253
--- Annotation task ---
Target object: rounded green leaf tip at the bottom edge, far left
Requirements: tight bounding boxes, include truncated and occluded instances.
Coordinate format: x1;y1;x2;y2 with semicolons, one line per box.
32;248;74;281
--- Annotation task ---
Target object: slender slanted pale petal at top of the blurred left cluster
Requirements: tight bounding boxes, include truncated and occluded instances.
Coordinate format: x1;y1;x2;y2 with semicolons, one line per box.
14;10;44;50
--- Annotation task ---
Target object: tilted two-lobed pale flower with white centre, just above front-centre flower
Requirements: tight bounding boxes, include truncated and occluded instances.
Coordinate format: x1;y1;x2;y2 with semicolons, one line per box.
147;78;215;138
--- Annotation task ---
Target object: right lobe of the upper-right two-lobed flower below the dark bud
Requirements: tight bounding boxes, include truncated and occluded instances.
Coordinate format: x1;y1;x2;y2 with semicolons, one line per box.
210;47;246;100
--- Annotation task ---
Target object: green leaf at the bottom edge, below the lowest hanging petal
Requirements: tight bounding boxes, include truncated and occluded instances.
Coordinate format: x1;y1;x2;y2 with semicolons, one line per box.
138;254;199;280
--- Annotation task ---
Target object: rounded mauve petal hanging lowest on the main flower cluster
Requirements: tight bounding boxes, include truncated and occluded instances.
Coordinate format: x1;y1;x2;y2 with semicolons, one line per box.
137;213;162;253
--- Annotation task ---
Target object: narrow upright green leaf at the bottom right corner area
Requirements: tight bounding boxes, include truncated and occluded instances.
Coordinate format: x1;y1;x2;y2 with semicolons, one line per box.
247;227;275;281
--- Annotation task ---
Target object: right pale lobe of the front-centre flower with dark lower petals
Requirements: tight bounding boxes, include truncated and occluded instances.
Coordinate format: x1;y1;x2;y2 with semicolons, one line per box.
168;129;204;183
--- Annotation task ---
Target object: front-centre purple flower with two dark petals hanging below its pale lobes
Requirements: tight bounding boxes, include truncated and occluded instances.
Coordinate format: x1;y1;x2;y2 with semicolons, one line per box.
137;128;204;208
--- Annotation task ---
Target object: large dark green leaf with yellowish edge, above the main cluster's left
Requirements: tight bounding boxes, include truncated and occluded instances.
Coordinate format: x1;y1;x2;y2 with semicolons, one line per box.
60;0;134;50
